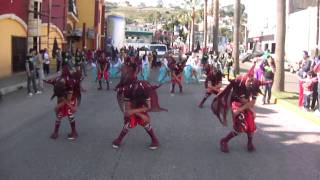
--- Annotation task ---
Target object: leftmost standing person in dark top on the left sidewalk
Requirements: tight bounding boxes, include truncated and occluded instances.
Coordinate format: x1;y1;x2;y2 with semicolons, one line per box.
25;49;40;96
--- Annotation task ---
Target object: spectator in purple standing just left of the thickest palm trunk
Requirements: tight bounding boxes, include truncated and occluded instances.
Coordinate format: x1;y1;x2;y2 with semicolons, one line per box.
261;56;276;104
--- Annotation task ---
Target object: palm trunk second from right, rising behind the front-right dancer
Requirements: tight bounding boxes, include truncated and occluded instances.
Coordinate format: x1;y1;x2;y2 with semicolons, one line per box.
233;0;240;74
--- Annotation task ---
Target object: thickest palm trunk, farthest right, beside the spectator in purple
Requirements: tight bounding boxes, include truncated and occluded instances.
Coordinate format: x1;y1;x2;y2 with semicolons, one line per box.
273;0;286;91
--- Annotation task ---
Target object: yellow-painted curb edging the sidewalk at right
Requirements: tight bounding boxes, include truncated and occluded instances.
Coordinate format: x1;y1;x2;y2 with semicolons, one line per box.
272;97;320;126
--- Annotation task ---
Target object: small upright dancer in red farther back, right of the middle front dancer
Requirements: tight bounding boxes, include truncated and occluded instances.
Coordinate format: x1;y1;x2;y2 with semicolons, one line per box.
169;59;185;94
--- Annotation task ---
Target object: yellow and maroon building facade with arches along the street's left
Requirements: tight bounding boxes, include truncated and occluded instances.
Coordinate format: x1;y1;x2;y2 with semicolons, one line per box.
0;0;105;78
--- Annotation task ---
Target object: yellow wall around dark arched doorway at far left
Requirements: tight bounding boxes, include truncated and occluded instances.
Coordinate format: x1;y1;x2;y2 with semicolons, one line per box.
0;17;27;78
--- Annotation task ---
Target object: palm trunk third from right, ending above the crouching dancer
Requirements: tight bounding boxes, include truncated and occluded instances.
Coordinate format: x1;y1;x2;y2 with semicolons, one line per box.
212;0;219;53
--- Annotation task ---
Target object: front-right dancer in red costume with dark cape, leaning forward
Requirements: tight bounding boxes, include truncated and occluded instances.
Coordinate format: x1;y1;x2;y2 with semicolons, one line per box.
211;64;265;153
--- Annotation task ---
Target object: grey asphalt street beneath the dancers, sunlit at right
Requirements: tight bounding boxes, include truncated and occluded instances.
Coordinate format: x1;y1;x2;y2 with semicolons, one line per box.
0;68;320;180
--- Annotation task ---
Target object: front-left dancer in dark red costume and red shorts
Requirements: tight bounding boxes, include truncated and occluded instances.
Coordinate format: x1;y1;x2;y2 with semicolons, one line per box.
45;65;81;140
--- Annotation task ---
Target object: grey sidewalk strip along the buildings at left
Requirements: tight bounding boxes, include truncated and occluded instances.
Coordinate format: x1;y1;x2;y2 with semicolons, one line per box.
0;68;56;99
